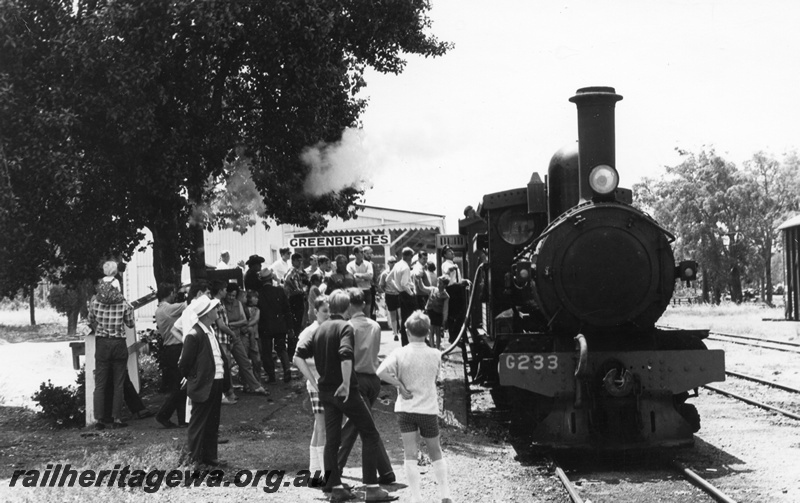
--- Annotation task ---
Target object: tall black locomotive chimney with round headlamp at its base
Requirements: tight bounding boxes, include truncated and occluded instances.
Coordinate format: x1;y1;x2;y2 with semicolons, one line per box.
569;87;622;201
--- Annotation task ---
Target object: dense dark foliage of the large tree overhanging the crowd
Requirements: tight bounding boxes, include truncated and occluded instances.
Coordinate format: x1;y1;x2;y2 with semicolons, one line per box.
0;0;450;296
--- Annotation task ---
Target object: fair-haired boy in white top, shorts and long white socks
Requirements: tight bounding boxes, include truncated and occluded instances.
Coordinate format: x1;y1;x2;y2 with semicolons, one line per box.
377;310;451;503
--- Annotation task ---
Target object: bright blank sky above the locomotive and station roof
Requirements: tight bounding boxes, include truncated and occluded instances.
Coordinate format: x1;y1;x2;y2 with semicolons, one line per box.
342;0;800;234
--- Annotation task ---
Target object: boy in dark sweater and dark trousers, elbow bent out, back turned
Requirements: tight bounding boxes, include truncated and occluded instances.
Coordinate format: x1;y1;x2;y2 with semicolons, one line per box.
294;291;398;501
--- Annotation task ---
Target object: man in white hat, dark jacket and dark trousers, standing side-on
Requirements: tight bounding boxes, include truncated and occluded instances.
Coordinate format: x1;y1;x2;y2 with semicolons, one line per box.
179;295;228;466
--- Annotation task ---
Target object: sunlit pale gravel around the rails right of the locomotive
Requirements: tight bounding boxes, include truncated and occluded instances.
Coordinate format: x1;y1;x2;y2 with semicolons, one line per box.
662;310;800;503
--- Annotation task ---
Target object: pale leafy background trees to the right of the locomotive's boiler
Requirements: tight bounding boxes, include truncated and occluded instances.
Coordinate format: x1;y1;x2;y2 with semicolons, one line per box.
634;149;800;303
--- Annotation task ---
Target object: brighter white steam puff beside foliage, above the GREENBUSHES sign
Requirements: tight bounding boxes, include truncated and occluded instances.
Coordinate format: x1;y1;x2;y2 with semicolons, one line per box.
300;128;377;196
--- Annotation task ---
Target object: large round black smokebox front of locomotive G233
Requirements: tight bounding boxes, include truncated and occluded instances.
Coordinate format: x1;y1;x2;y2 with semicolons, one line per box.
534;203;675;333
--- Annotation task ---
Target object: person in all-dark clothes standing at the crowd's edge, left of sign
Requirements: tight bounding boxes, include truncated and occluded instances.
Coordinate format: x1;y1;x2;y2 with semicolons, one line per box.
258;267;294;383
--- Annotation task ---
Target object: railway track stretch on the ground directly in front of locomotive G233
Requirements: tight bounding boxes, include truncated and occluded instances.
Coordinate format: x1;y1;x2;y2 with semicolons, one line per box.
550;453;735;503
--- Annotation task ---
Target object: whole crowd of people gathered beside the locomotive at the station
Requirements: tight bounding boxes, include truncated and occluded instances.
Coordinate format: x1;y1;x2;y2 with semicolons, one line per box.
89;247;468;502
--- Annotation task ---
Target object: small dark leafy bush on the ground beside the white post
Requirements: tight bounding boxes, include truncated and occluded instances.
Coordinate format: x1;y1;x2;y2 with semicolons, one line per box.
31;369;86;428
